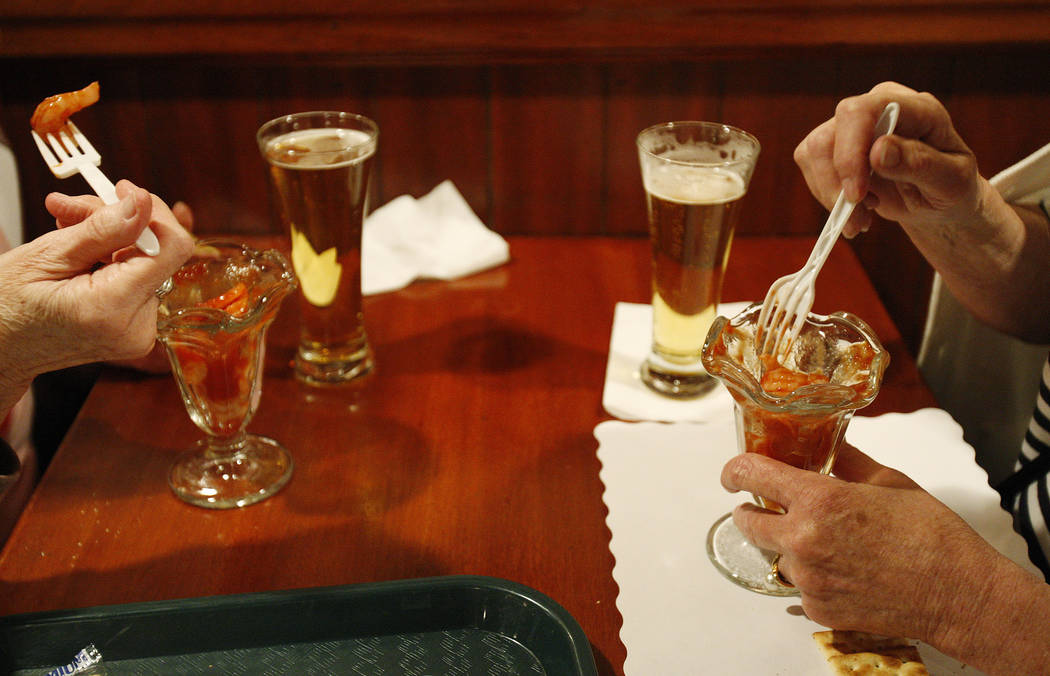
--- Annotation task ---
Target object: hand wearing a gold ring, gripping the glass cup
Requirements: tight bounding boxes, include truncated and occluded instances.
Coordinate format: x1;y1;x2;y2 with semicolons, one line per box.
721;444;1001;645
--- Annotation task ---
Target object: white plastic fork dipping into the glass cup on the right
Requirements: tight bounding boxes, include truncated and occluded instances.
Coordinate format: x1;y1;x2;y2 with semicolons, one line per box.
755;102;901;356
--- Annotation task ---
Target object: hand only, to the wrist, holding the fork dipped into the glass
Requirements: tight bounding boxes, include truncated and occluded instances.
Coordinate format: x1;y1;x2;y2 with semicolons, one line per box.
795;82;990;237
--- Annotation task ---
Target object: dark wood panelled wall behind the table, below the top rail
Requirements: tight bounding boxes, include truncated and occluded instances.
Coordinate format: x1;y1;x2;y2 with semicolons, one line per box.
0;36;1050;350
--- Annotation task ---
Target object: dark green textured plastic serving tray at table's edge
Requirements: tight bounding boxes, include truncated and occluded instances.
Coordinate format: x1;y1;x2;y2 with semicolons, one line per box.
0;576;597;676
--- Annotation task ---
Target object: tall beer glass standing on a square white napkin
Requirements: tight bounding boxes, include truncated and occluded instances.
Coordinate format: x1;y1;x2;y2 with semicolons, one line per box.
637;122;760;398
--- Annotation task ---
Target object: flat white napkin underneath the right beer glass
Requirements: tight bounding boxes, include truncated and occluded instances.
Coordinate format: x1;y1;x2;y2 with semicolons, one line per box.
602;302;750;422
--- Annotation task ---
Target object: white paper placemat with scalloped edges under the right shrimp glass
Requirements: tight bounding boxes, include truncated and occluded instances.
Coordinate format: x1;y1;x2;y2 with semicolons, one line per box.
594;408;1035;676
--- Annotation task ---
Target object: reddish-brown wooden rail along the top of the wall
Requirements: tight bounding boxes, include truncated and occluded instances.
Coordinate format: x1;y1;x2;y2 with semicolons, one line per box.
0;0;1048;59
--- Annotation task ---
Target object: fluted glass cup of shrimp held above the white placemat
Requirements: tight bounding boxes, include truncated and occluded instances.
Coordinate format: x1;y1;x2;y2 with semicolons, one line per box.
702;304;889;596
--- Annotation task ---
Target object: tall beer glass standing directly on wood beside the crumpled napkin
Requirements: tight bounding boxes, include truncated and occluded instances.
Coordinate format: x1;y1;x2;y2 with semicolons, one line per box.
257;111;379;385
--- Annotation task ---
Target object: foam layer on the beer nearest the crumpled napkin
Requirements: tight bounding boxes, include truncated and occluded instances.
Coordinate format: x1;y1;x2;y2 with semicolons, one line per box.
267;127;376;169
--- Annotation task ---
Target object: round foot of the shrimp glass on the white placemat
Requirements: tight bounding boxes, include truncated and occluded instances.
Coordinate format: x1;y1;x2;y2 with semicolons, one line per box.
708;513;799;596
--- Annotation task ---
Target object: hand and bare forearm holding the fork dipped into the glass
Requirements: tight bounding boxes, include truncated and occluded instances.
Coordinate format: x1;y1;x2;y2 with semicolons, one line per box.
795;82;1050;343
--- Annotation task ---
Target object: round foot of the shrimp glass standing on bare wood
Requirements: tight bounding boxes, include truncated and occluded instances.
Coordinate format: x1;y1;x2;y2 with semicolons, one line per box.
168;435;292;509
